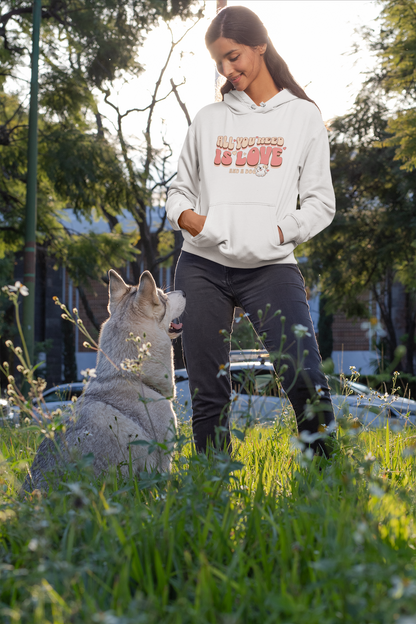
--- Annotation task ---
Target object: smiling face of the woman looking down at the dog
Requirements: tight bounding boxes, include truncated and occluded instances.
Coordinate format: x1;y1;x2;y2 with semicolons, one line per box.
209;37;267;91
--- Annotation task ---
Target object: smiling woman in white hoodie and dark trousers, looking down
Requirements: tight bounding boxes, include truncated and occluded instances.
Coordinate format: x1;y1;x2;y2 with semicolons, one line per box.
166;6;335;452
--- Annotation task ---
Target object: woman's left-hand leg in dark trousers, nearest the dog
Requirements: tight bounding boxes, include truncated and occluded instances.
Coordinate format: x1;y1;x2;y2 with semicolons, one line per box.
175;252;235;452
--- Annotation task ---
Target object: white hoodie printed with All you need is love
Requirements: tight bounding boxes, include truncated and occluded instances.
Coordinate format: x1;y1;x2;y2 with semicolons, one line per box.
166;89;335;268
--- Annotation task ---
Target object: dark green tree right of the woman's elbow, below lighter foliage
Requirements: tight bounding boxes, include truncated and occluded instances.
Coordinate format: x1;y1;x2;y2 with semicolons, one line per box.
303;88;416;374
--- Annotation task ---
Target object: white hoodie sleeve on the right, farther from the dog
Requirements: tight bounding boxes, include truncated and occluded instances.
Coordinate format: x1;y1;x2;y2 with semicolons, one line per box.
277;118;335;245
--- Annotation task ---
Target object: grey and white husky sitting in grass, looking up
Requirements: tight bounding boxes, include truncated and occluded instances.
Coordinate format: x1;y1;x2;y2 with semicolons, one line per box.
22;270;185;494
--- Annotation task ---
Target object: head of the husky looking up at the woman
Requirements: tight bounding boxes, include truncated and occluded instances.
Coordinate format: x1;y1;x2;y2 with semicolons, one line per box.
108;269;185;339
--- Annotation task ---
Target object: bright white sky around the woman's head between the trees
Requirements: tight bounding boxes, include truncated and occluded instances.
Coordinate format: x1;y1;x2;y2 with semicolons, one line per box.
97;0;380;170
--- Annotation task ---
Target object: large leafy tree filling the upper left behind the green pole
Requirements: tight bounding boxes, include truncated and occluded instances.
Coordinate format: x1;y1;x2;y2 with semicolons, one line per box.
0;0;202;332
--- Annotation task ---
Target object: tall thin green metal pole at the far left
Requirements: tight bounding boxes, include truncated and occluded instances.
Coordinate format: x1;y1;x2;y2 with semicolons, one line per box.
23;0;41;364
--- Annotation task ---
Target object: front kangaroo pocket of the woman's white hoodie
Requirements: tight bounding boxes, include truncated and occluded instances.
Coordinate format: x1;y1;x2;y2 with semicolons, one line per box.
186;202;280;264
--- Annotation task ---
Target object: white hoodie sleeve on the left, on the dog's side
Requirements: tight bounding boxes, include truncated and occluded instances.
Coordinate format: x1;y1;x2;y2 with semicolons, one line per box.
166;126;200;230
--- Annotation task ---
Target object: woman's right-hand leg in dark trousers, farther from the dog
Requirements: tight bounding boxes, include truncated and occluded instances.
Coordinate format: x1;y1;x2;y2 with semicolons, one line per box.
232;264;334;452
